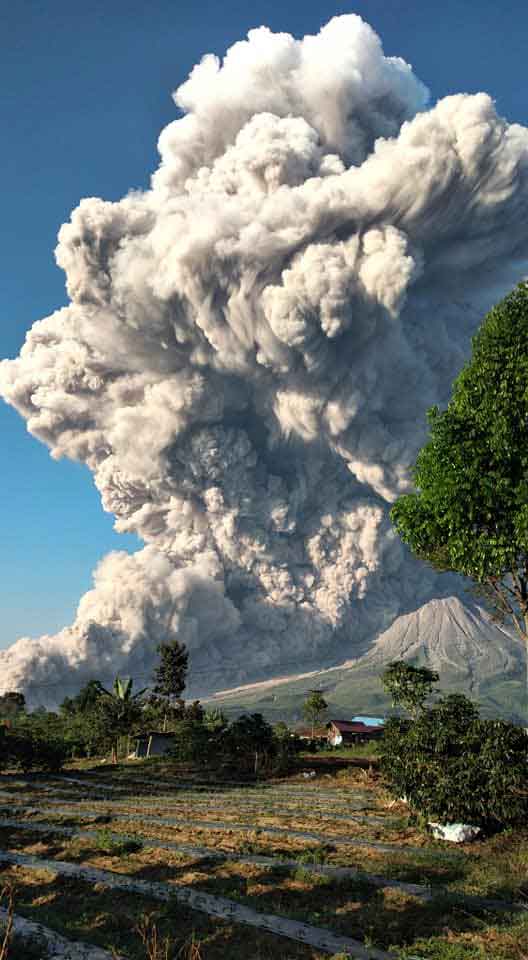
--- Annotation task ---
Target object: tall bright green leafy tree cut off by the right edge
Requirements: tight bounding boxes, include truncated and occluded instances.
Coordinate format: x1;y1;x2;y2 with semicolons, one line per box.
391;283;528;700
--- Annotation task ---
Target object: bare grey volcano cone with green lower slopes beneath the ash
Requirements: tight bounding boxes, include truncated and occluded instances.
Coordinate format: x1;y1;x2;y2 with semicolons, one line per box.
207;597;528;723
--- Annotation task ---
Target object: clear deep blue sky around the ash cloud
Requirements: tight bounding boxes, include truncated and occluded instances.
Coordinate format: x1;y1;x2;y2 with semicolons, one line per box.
0;0;528;647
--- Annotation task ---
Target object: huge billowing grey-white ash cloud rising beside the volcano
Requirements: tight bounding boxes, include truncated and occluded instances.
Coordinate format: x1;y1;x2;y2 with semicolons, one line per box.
0;16;528;701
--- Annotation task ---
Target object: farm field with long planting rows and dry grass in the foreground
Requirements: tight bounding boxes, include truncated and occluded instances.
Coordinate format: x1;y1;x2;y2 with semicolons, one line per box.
0;761;528;960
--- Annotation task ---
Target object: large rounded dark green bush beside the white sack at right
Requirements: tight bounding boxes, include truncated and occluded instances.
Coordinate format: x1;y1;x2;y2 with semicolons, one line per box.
381;694;528;829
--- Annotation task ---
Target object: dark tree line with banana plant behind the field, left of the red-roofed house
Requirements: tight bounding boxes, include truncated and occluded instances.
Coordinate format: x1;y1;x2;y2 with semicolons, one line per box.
0;640;301;773
